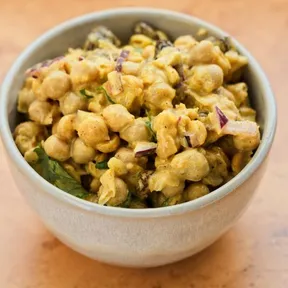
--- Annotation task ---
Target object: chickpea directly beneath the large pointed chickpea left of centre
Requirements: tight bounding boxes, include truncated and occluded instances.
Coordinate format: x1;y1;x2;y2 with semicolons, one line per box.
71;138;96;164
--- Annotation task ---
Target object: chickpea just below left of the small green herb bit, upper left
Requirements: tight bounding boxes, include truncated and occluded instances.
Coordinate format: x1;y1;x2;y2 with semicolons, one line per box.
59;92;88;115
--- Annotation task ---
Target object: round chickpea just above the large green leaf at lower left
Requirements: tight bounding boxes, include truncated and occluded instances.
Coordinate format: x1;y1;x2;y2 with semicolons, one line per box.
43;135;70;162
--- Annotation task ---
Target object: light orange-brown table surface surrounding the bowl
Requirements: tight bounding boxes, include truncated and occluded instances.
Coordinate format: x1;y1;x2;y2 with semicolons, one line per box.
0;0;288;288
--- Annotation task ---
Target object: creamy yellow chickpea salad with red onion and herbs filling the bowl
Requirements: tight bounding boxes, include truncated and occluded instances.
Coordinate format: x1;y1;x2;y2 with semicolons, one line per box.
14;22;260;208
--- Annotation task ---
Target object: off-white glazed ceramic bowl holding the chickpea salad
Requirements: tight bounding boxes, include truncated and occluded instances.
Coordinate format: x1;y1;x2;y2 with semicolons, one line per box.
0;8;276;267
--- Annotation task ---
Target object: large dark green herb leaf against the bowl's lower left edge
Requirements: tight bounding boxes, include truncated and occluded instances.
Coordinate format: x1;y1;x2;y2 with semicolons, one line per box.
34;146;90;199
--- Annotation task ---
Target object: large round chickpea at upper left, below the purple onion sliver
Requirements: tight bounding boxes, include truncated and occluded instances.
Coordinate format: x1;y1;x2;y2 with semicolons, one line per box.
41;71;71;100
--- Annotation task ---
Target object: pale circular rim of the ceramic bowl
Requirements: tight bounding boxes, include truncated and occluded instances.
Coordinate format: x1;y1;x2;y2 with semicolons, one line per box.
0;7;277;218
